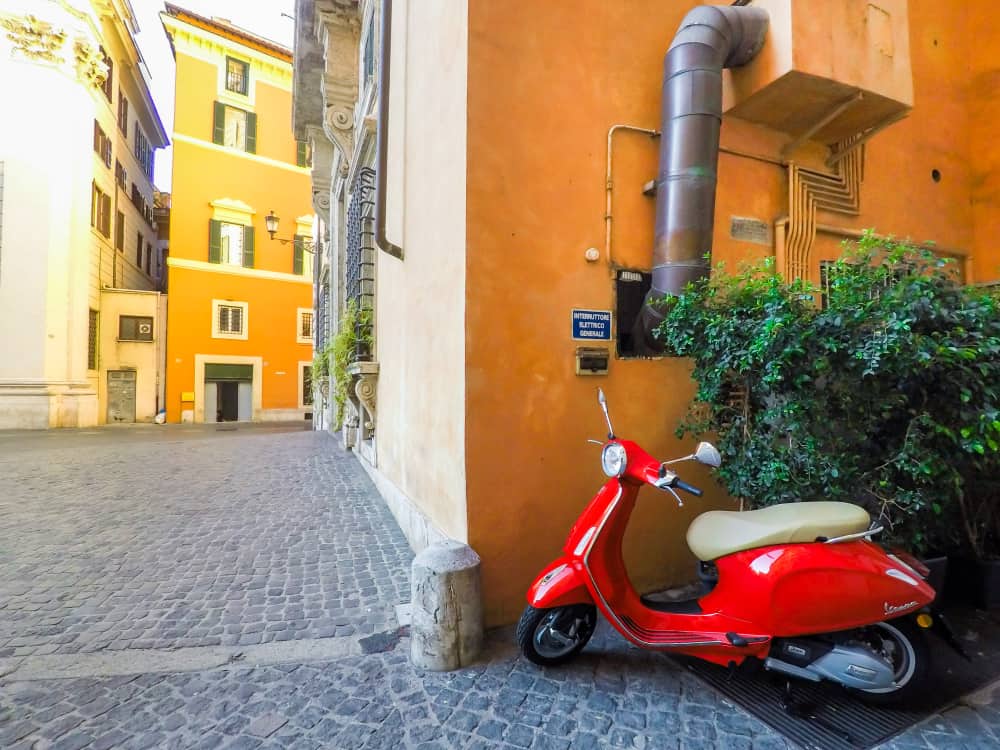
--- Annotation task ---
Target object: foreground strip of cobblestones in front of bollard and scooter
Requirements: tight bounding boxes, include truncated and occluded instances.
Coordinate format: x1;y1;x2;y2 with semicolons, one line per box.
0;630;789;750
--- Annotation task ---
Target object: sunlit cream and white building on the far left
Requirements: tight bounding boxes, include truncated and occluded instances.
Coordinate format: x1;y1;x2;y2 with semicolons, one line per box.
0;0;168;429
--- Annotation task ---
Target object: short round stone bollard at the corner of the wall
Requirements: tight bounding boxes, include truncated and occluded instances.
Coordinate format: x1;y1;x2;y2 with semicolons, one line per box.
410;539;483;672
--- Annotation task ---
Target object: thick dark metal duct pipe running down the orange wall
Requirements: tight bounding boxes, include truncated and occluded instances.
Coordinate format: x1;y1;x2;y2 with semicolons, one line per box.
633;5;768;355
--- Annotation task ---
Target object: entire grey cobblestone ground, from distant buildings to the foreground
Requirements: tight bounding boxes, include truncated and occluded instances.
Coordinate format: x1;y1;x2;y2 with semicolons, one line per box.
0;427;1000;750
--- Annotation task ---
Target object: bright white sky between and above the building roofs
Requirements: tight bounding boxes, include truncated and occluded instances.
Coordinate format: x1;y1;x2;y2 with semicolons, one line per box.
131;0;295;191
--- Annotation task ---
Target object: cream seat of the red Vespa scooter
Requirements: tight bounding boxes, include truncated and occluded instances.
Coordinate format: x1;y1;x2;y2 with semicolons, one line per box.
687;501;870;561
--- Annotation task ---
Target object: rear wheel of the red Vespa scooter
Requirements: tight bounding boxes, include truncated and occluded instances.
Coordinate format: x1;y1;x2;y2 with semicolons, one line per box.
853;618;930;706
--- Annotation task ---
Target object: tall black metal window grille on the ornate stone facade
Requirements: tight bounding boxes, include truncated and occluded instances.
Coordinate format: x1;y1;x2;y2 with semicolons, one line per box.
344;167;375;362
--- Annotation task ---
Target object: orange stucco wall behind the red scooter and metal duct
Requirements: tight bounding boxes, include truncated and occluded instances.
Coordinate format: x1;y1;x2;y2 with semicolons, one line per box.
466;0;1000;624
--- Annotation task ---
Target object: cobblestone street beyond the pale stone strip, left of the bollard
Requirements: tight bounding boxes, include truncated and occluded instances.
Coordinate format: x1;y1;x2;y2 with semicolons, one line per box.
0;425;412;659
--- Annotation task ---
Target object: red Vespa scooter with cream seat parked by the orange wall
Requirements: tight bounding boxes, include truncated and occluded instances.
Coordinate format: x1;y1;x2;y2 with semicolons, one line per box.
517;390;935;703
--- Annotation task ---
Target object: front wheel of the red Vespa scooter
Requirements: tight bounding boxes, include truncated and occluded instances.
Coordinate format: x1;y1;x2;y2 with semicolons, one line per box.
517;604;597;667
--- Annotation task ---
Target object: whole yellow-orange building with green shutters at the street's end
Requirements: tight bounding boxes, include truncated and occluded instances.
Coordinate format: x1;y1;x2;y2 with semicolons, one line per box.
161;4;313;422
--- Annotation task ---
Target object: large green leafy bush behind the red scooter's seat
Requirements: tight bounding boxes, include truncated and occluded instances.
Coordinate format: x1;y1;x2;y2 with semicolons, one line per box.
657;232;1000;558
